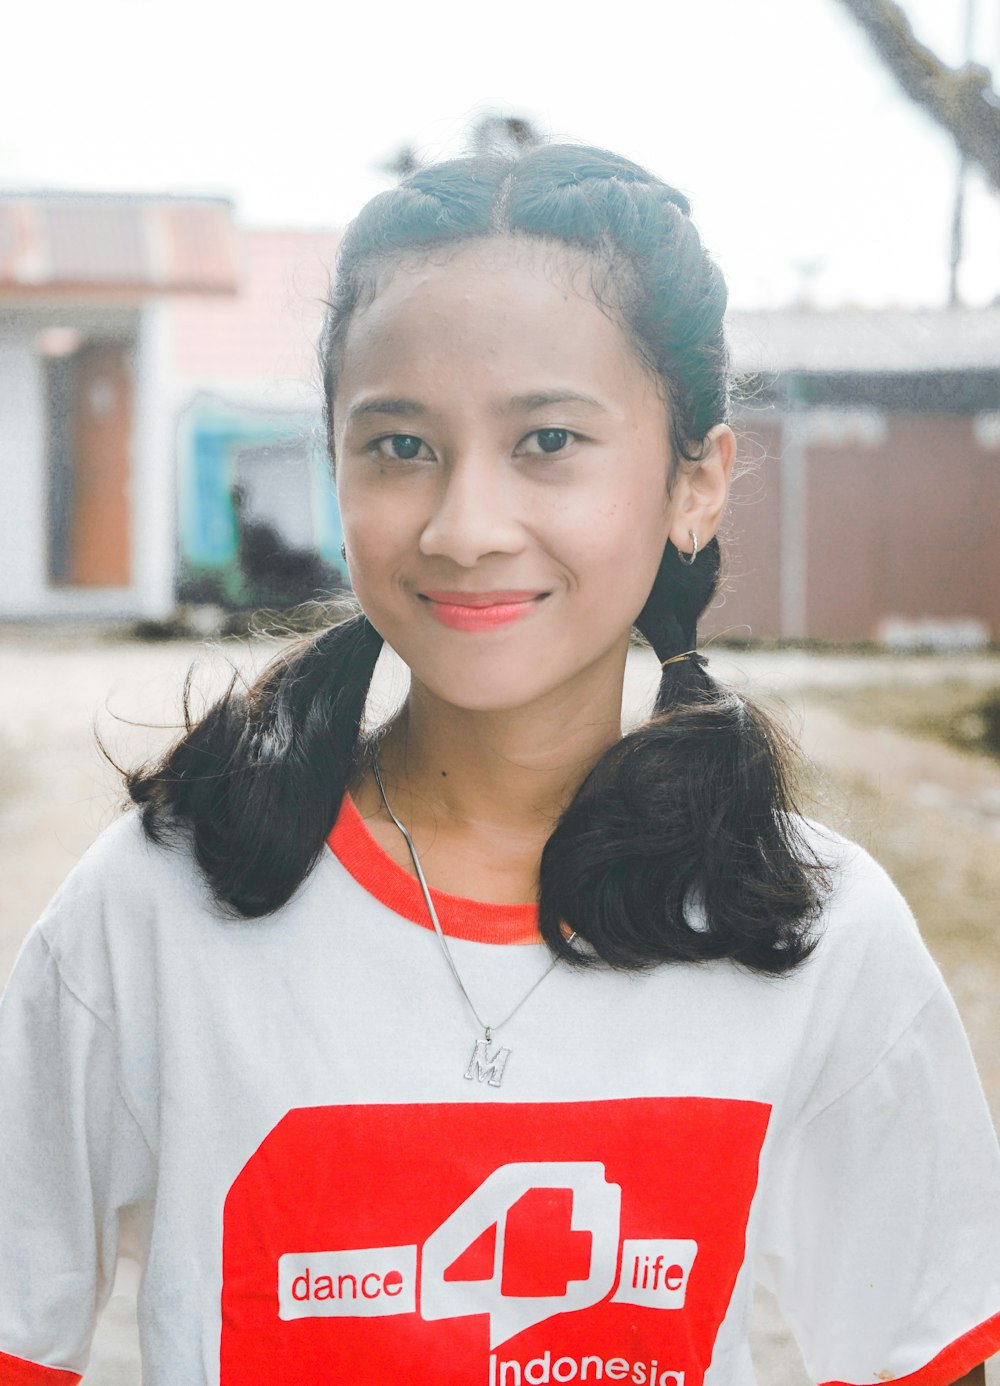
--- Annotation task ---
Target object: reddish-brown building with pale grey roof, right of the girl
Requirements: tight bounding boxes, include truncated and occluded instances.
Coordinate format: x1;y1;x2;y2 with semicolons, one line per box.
706;309;1000;647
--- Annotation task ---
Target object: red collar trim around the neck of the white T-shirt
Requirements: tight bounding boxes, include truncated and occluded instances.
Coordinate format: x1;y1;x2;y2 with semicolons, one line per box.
327;794;540;944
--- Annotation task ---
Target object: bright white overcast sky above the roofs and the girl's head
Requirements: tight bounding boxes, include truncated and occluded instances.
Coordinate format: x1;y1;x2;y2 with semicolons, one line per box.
0;0;1000;306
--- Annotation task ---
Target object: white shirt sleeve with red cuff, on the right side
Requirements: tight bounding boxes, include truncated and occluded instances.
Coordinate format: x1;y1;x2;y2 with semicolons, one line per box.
758;984;1000;1386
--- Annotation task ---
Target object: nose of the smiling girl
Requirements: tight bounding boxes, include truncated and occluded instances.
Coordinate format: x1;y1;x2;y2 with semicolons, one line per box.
420;459;525;568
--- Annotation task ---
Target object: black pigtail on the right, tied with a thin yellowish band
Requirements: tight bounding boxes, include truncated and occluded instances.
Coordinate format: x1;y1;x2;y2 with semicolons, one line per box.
539;541;823;974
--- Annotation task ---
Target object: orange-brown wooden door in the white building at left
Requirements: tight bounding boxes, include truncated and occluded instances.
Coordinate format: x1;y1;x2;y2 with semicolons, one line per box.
66;342;132;588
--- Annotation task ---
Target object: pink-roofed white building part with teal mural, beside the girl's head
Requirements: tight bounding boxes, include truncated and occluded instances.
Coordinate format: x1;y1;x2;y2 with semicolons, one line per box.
166;230;345;607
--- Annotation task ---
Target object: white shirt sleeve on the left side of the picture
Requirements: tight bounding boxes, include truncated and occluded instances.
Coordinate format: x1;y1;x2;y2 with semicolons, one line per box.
0;929;151;1386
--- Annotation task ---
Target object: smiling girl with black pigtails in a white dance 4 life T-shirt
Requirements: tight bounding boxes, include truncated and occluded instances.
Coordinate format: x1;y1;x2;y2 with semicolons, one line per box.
0;146;1000;1386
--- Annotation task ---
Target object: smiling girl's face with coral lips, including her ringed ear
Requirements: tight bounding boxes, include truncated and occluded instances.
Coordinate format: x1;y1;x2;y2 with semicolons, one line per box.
334;240;731;711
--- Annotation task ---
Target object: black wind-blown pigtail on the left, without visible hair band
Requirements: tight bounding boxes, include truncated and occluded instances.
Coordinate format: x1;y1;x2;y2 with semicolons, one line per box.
126;615;382;918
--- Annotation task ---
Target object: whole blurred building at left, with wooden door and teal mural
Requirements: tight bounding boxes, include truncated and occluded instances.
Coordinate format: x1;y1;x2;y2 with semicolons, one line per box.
0;194;342;620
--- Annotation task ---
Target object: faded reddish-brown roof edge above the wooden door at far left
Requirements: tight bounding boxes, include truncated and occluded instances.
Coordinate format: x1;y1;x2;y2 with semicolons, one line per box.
0;193;237;299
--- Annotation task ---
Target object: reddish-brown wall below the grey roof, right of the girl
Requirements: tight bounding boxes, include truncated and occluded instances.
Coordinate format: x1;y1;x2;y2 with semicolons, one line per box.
692;414;1000;640
